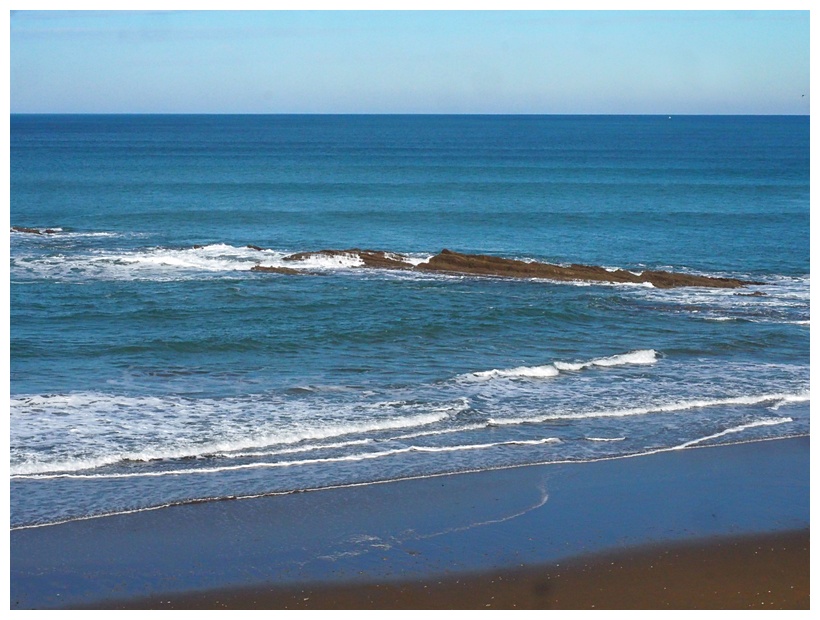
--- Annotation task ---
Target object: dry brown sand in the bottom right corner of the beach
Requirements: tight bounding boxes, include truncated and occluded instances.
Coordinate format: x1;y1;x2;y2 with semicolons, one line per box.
94;529;810;610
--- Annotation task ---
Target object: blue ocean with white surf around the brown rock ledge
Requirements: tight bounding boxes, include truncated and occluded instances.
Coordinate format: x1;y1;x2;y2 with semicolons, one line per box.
9;115;810;528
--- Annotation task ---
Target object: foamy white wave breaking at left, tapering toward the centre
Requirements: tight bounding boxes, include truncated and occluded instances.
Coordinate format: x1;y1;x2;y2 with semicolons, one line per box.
10;393;469;475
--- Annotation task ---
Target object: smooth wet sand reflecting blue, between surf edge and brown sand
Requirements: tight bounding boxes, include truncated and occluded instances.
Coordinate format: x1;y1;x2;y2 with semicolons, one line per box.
10;436;810;609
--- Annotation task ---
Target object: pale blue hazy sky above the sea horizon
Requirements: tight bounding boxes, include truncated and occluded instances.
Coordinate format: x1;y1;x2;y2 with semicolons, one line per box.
10;11;810;114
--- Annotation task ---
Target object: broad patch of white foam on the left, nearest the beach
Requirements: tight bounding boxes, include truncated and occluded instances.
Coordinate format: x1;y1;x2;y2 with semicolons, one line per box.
10;392;458;475
